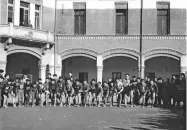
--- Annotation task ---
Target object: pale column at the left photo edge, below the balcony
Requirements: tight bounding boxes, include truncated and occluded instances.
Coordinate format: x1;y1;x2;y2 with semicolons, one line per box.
0;43;7;74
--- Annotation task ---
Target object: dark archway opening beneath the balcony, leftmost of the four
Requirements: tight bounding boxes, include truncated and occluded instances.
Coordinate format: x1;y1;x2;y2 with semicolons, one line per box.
6;52;40;81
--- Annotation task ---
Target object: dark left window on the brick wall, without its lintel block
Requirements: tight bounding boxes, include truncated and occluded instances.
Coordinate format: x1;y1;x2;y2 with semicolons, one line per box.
74;9;86;34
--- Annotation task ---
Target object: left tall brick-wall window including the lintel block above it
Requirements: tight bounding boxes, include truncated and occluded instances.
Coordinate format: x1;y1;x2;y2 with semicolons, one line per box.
74;2;86;34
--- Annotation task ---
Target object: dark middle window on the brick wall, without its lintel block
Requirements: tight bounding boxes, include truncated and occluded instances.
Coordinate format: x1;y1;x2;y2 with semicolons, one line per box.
116;9;128;34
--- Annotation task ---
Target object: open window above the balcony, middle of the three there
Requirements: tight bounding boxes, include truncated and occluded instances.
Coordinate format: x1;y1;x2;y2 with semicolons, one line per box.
20;1;29;25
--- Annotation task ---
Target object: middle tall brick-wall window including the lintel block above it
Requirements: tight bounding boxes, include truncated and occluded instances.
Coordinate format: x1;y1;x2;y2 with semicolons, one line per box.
115;2;128;34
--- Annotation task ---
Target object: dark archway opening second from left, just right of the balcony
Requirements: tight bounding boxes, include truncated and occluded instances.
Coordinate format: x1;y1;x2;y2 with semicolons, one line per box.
62;56;97;81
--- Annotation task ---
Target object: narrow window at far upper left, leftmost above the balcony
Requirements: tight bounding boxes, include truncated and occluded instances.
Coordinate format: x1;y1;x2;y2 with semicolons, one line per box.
8;0;14;23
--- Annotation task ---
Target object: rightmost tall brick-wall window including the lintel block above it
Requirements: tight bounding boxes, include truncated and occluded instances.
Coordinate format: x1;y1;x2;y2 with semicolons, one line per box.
157;2;170;35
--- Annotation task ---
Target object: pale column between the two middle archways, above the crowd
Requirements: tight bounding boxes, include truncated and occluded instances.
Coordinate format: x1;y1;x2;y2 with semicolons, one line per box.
97;55;103;82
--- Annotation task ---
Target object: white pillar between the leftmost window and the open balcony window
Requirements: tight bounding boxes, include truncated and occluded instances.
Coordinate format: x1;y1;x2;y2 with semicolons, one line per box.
14;0;20;26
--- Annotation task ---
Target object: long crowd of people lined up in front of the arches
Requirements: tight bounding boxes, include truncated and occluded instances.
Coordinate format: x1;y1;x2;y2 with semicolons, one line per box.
0;70;186;108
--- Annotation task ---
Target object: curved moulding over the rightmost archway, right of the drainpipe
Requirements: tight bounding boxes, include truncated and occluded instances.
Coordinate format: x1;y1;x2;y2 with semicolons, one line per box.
143;48;184;61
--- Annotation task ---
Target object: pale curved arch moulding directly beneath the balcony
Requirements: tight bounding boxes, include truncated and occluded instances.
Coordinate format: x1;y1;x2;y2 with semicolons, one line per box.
7;47;42;59
